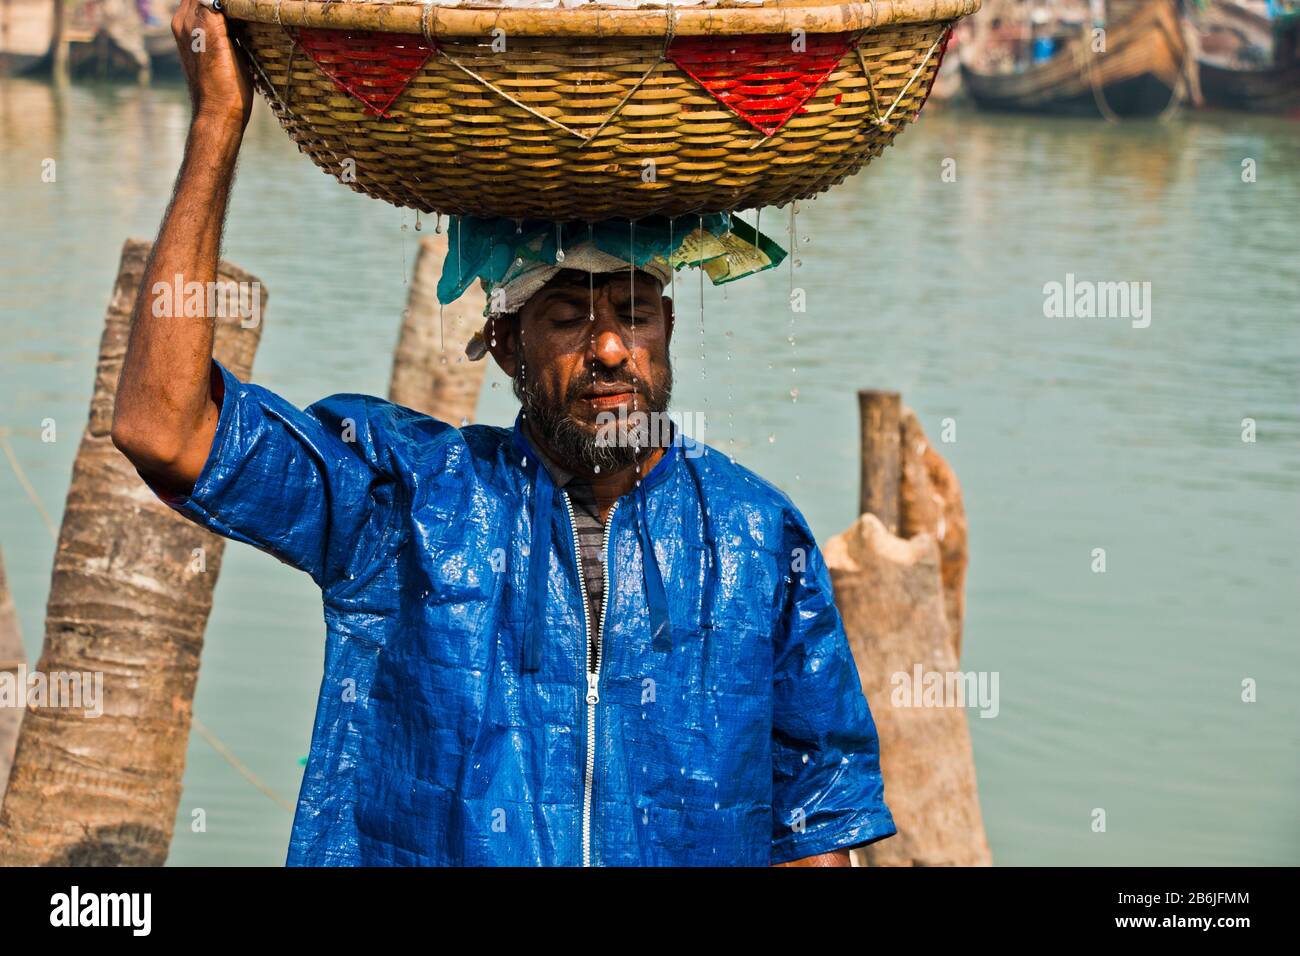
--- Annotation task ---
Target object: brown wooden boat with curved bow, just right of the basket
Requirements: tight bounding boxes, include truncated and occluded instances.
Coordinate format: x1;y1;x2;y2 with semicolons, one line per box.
962;0;1190;118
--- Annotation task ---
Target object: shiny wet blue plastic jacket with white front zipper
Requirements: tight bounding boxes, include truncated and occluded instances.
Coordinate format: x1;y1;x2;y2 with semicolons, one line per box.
172;367;894;866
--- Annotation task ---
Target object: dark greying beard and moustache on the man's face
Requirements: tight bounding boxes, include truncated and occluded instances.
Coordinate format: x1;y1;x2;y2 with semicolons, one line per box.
514;363;672;475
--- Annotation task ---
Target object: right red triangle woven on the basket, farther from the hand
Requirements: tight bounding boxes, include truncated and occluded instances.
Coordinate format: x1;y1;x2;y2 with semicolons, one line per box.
668;31;858;135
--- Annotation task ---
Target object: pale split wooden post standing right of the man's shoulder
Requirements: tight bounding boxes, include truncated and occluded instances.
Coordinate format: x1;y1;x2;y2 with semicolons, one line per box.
823;392;997;866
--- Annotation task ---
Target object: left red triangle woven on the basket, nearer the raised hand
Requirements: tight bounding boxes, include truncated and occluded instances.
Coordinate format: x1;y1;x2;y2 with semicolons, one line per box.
294;26;434;116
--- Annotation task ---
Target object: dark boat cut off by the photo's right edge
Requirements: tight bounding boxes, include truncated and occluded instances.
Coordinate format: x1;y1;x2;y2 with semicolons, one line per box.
1196;0;1300;113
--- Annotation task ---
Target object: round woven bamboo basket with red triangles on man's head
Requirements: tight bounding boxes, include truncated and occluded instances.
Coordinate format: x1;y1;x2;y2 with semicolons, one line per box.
224;0;980;221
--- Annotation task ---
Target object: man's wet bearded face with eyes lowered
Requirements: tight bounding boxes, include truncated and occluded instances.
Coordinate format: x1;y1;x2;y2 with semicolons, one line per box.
488;269;672;475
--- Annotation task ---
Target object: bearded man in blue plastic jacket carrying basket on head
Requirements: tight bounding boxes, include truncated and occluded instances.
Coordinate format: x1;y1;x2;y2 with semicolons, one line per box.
113;0;894;866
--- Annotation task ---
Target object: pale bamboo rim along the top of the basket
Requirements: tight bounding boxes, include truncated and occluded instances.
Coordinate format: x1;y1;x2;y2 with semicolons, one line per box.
222;0;982;39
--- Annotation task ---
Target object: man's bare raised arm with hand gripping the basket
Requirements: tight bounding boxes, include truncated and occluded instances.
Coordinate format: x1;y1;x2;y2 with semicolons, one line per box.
113;0;252;493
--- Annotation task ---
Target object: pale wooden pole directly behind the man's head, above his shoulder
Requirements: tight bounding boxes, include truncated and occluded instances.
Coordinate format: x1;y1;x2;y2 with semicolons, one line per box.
389;234;488;427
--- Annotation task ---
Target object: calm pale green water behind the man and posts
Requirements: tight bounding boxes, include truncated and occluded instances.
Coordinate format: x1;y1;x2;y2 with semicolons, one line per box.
0;81;1300;865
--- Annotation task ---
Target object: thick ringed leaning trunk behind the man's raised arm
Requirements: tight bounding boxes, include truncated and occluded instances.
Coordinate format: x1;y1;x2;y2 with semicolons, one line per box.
0;239;265;866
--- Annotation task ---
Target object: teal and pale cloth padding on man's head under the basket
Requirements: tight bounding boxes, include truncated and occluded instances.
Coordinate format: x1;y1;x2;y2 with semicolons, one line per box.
438;212;785;315
